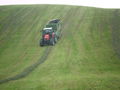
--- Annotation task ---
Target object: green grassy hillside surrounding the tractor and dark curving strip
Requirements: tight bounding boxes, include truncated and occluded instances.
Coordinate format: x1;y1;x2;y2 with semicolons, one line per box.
0;5;120;90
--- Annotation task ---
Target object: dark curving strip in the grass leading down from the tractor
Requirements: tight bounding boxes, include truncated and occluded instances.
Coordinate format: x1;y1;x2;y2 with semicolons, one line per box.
0;46;53;84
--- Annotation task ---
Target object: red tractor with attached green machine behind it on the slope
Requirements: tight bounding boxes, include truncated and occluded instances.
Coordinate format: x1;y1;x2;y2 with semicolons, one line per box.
40;19;61;46
